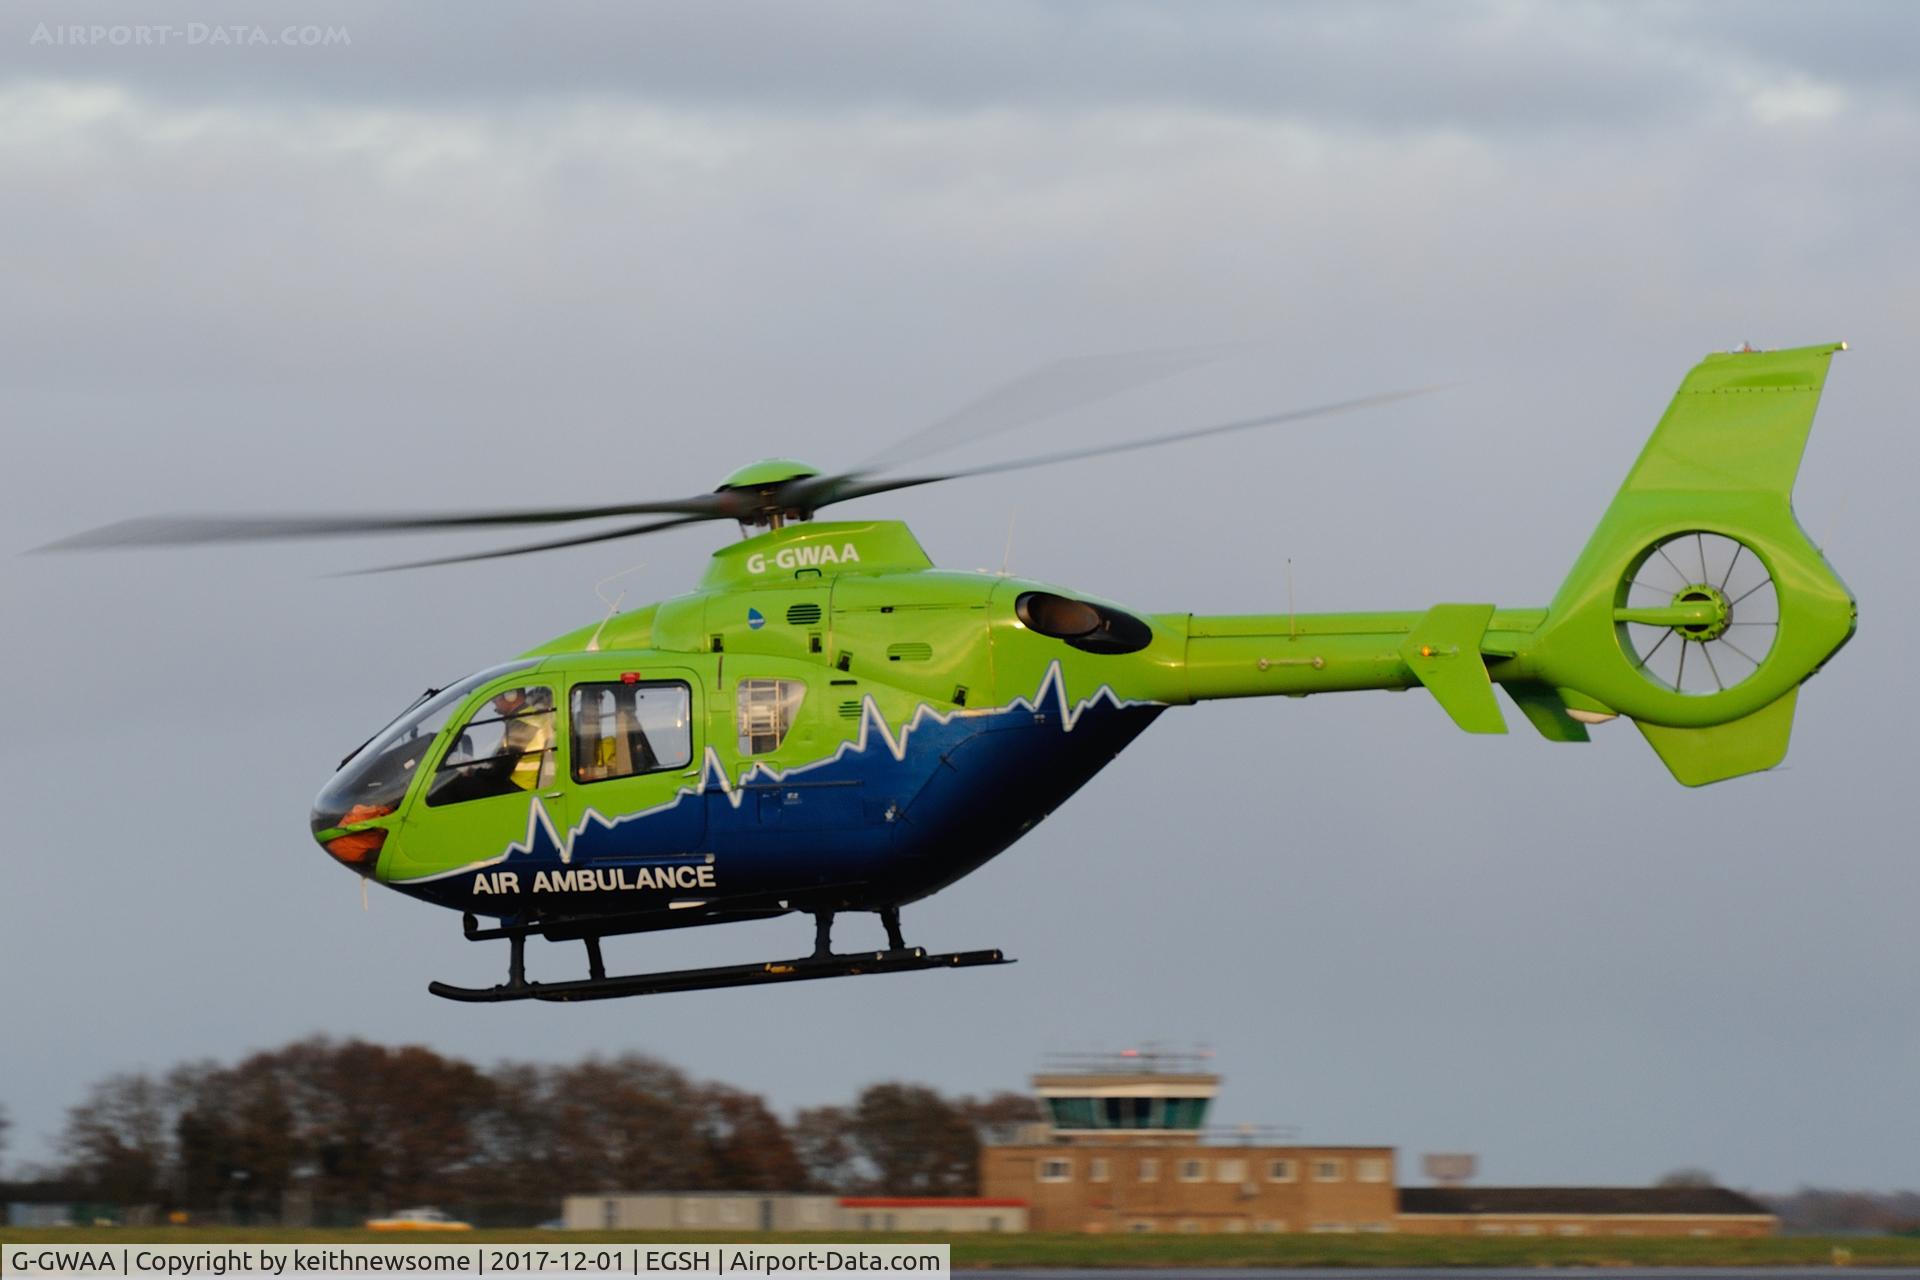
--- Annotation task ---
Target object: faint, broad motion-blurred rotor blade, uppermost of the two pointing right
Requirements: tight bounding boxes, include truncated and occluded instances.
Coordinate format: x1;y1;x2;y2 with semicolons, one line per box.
854;344;1244;472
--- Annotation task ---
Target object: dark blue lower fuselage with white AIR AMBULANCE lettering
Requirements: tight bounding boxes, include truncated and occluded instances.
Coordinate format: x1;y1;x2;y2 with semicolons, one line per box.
392;697;1164;931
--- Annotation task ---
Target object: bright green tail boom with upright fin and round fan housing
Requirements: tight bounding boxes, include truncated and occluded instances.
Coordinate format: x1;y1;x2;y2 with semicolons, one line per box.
1158;344;1857;785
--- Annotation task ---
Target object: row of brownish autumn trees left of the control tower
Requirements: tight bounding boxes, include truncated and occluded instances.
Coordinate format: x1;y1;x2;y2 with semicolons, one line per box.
30;1038;1039;1224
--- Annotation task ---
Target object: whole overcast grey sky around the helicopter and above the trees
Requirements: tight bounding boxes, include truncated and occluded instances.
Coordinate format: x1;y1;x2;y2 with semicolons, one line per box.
0;0;1920;1192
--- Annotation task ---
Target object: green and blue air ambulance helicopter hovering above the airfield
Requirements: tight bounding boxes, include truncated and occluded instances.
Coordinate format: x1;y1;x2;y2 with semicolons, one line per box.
52;344;1857;1002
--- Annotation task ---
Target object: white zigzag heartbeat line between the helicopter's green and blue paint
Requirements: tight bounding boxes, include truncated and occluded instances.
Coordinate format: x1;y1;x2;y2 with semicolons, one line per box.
403;658;1160;885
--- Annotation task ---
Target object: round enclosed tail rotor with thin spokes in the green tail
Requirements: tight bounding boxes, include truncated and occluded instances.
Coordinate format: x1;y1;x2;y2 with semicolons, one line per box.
1613;530;1780;695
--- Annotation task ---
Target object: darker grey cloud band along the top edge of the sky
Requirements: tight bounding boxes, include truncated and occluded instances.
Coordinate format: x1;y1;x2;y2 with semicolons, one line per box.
0;0;1912;132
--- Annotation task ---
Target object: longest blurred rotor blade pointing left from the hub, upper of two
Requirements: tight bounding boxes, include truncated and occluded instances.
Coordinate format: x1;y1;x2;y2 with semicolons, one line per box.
36;493;737;551
